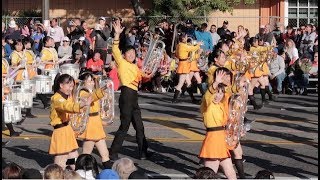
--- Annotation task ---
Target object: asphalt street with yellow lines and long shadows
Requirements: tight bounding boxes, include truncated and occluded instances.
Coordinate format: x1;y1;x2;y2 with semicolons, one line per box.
2;93;318;179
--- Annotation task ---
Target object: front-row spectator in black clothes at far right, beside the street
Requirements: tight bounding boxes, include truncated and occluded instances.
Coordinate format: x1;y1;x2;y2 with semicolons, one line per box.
288;53;312;95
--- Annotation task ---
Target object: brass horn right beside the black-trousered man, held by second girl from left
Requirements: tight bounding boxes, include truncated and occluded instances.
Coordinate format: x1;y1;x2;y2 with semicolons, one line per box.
96;76;114;125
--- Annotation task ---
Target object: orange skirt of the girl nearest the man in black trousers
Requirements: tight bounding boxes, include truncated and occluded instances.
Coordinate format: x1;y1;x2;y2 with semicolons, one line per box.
78;116;106;141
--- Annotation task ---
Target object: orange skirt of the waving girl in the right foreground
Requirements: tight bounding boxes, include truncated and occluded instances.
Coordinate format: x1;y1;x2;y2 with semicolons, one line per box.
199;130;230;159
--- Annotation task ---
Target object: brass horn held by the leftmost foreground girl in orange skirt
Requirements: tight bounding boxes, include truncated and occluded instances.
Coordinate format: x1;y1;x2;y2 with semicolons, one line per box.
69;81;91;136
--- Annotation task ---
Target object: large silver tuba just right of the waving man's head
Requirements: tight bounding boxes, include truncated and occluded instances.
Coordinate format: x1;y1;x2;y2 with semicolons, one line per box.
142;32;166;74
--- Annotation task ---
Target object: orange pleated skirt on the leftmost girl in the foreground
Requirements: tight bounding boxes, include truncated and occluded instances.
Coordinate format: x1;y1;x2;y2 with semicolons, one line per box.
49;125;79;155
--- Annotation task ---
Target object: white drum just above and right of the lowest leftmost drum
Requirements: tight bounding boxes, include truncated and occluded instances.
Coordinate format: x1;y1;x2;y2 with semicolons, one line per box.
10;88;33;108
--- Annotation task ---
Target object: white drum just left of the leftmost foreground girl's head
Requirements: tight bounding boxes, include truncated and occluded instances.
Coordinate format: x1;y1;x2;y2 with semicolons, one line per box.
33;75;52;94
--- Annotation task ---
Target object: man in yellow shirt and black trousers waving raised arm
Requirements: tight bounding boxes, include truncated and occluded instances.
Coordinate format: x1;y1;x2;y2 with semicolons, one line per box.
110;20;152;160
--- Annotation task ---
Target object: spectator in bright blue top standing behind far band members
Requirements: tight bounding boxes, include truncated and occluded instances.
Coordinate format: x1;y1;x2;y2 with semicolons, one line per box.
195;23;213;54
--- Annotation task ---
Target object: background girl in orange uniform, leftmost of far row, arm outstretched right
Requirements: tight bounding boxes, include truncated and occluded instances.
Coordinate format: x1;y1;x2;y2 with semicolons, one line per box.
172;33;202;103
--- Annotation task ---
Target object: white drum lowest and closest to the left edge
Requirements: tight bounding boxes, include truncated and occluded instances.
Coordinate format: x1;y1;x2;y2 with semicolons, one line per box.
2;100;22;124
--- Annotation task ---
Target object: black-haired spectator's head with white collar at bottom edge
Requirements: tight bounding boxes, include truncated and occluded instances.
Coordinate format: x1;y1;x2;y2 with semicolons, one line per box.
75;154;99;179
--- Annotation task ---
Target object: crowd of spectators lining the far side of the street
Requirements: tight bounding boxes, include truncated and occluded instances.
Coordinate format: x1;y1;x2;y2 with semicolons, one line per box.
2;17;318;94
